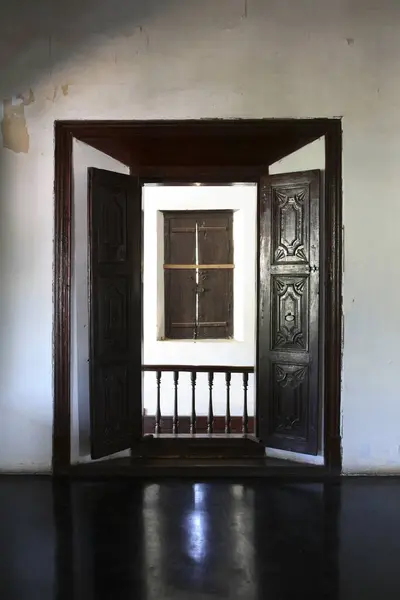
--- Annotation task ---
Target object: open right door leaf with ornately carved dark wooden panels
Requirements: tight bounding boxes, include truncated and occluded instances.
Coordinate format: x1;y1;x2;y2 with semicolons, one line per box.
257;171;320;454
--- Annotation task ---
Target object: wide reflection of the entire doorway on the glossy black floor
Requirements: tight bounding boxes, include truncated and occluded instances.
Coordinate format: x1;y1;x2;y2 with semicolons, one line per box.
54;481;338;600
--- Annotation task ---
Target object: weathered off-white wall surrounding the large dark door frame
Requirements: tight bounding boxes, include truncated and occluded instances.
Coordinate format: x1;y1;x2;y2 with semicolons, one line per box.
0;0;400;472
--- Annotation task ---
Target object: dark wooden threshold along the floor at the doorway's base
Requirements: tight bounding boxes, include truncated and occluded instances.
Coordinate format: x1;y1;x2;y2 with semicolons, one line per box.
69;457;329;480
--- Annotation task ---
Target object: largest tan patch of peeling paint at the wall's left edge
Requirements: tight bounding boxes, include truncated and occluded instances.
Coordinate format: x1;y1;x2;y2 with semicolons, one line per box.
1;89;35;154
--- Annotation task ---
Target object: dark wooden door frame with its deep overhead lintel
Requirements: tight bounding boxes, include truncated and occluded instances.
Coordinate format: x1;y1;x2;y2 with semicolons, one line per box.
53;119;342;474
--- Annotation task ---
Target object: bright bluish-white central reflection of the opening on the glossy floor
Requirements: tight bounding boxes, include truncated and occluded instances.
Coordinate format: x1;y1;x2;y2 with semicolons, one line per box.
144;483;256;598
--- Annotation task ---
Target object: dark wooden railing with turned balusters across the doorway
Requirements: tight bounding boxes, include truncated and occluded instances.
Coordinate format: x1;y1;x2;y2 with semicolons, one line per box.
142;365;254;435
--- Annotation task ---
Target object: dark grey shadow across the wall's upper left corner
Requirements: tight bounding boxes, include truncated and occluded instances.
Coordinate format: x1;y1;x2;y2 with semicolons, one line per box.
0;0;165;99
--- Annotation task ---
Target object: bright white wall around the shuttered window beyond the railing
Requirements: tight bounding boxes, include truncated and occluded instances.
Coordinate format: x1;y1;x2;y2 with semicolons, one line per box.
143;185;257;416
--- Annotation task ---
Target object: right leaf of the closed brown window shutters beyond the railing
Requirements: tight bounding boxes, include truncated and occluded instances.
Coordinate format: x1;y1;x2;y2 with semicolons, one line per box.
197;211;233;339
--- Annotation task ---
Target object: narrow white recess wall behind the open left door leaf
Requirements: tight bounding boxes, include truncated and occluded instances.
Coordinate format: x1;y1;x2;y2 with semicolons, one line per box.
71;139;129;463
